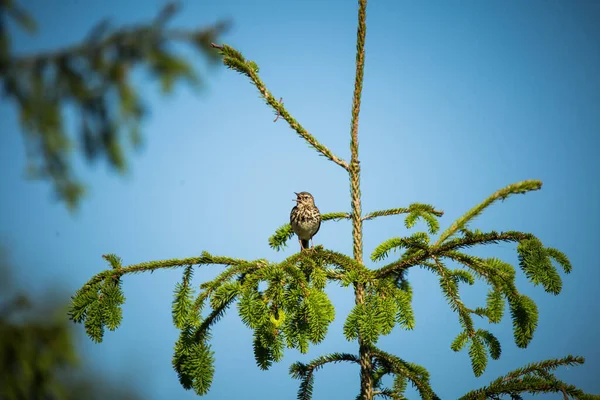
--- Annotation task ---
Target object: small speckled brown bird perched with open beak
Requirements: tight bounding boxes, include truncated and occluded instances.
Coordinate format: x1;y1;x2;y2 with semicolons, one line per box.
290;192;321;251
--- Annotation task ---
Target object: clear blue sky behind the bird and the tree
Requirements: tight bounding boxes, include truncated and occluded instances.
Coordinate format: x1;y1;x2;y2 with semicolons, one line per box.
0;0;600;400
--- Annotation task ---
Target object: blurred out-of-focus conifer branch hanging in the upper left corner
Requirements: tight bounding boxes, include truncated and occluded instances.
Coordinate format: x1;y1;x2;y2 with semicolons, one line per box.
0;0;227;209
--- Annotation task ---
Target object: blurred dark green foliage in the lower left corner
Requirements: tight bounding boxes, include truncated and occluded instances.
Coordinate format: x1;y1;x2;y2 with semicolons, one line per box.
0;247;141;400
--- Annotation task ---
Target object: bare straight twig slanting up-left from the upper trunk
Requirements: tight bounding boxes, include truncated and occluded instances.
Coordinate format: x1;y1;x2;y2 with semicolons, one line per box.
211;43;348;170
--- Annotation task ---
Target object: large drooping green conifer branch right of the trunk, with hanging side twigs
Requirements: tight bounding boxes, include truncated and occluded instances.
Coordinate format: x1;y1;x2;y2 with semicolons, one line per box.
373;229;570;376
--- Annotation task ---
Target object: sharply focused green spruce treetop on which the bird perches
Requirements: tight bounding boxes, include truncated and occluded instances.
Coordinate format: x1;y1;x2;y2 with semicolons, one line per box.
69;0;600;400
